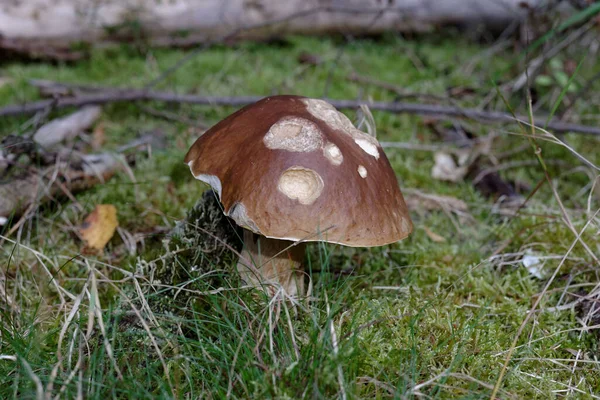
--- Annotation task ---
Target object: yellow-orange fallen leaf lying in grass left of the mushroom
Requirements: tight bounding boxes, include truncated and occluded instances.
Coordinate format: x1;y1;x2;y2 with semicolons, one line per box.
79;204;119;250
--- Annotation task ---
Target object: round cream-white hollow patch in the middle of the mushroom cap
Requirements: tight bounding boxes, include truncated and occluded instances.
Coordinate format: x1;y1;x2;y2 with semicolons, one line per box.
277;167;324;205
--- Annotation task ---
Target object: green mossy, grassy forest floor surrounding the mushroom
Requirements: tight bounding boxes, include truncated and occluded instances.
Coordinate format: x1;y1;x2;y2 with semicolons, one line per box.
0;30;600;399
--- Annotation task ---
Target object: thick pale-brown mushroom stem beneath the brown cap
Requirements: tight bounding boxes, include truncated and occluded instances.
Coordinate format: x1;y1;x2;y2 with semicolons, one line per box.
237;229;305;296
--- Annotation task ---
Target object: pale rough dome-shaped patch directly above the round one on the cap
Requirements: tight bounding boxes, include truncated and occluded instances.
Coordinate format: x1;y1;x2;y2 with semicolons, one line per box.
263;117;323;152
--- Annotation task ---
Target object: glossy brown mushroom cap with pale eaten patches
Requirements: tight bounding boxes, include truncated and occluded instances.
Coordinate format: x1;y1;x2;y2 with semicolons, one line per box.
185;96;412;247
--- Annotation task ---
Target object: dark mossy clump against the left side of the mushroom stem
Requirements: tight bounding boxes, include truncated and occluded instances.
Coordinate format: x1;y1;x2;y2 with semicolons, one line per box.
127;190;242;314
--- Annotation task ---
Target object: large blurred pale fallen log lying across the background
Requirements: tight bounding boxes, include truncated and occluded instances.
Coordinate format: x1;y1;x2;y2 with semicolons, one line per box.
0;0;544;59
